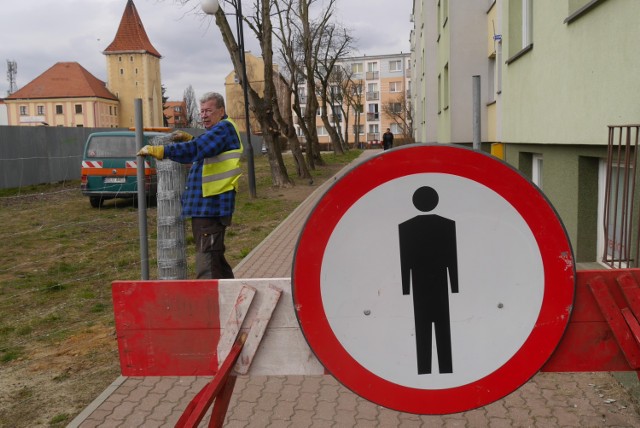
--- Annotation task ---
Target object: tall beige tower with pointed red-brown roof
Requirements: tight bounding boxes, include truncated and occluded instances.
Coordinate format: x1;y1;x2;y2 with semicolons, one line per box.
103;0;163;128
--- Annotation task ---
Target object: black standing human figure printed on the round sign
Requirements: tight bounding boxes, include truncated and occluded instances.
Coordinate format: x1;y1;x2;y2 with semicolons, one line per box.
398;186;458;374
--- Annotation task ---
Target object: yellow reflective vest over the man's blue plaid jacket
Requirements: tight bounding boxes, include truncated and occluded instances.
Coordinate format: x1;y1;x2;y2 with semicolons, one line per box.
202;118;242;197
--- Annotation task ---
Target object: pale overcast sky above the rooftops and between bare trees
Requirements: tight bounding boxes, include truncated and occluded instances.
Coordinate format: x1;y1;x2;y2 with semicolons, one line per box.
0;0;413;100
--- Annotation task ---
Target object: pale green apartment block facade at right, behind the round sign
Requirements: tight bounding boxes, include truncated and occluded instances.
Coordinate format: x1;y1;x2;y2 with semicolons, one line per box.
411;0;640;262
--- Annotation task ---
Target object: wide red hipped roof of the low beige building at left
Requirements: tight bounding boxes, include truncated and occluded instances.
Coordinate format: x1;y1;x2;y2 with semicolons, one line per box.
6;62;118;100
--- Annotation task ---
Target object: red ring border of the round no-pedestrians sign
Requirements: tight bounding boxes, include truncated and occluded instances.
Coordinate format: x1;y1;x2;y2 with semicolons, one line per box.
291;144;576;414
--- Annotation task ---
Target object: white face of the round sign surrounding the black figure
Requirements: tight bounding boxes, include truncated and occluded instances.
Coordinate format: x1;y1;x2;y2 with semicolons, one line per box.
321;173;544;389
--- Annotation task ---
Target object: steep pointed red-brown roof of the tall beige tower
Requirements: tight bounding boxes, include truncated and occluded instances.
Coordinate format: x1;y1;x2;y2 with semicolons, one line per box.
104;0;161;58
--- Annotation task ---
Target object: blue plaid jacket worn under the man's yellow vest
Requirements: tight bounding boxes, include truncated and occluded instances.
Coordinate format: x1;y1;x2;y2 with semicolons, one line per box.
164;115;240;217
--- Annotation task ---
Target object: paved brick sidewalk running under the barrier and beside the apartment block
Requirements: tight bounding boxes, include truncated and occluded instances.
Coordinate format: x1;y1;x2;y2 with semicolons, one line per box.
69;150;640;428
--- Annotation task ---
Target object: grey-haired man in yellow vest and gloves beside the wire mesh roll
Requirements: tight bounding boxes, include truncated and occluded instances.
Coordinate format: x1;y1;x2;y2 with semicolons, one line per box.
138;92;242;279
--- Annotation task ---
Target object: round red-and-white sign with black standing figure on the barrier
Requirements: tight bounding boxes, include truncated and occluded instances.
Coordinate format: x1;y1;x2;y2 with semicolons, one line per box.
292;144;575;414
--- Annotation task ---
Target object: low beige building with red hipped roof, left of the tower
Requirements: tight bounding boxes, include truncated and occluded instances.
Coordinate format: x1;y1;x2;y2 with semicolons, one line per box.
5;62;119;128
